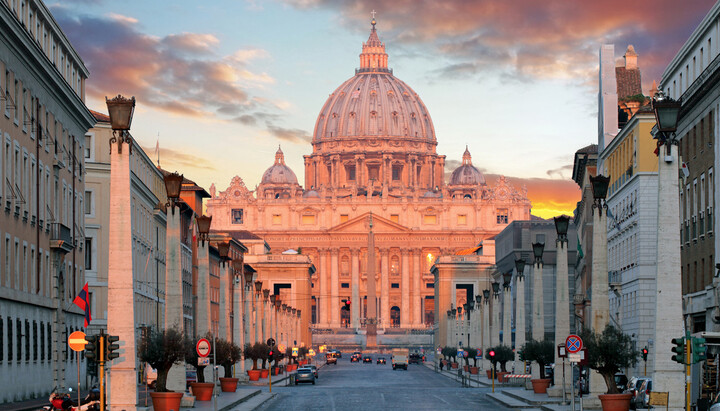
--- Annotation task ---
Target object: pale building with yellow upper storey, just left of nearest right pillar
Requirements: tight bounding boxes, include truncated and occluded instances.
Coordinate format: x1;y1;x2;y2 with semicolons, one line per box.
600;106;658;375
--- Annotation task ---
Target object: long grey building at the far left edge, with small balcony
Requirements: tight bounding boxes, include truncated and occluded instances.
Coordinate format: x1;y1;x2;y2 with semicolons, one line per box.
0;0;94;403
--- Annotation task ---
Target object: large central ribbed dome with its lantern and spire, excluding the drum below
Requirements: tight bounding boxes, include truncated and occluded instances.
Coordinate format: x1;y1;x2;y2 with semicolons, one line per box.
313;19;436;143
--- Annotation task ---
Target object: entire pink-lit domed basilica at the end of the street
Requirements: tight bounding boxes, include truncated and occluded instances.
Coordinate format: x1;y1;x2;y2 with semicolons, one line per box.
207;20;530;340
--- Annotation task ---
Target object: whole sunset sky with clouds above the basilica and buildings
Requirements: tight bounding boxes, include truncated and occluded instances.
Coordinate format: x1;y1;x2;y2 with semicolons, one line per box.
46;0;714;218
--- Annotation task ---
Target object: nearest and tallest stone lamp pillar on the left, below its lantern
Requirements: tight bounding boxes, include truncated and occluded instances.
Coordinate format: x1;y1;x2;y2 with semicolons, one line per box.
107;132;138;410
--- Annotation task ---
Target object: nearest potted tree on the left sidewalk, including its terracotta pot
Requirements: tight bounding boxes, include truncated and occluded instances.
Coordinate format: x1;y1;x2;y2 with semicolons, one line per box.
138;328;185;411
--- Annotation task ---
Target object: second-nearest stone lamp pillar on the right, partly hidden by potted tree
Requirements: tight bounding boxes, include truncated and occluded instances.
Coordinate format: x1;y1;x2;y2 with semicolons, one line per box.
590;206;612;398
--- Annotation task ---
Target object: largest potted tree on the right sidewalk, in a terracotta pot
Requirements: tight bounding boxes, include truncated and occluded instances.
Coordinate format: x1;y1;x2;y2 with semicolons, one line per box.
580;324;640;411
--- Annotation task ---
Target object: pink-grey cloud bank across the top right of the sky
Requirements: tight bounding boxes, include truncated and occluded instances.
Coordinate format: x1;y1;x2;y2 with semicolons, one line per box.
284;0;715;89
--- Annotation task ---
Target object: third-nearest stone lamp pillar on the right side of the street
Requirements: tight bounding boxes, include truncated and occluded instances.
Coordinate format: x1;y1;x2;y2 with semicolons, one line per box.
548;238;572;397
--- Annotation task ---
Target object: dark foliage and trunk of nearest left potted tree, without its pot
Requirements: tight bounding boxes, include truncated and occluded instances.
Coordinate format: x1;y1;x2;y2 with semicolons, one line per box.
138;328;185;392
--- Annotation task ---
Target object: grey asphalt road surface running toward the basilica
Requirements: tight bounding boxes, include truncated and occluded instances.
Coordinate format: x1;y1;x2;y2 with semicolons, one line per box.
260;354;504;411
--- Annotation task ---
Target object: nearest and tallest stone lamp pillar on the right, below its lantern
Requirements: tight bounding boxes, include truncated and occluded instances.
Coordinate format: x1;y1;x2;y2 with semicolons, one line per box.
652;144;685;410
